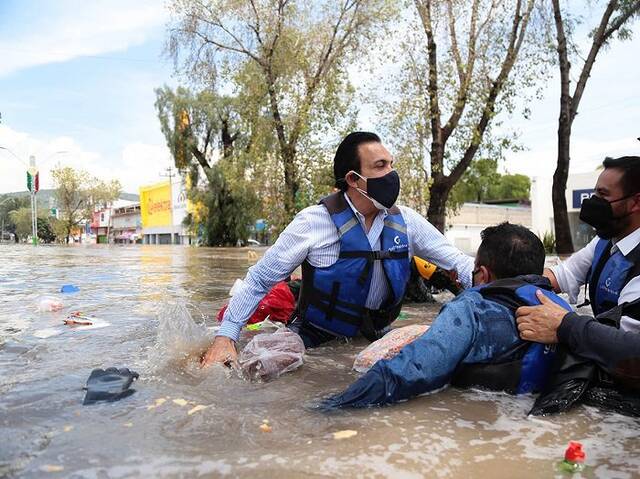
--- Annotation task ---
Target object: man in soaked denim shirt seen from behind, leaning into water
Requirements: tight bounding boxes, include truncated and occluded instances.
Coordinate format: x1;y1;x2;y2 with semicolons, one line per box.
323;223;571;408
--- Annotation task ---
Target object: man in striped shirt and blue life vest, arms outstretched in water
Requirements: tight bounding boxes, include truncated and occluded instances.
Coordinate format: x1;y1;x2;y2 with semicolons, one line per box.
202;132;473;365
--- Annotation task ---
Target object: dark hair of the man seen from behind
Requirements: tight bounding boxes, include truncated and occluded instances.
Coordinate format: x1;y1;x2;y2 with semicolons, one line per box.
476;221;545;279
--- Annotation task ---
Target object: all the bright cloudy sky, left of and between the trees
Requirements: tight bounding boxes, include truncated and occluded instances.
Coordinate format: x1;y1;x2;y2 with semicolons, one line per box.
0;0;640;193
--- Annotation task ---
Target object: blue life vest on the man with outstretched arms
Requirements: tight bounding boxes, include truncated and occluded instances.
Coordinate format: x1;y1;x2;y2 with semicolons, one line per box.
298;192;411;340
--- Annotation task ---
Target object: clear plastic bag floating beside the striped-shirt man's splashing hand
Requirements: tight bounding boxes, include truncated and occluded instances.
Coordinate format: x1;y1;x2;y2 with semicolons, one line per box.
238;328;305;381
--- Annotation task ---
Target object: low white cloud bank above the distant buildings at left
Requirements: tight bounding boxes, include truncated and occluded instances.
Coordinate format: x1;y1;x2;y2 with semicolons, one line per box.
0;126;171;198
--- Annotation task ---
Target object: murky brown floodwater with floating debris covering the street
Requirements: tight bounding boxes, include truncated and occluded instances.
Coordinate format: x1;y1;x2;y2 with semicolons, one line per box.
0;245;640;478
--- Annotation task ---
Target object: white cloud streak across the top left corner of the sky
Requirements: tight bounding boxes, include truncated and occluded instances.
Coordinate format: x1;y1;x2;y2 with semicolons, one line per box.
0;0;168;77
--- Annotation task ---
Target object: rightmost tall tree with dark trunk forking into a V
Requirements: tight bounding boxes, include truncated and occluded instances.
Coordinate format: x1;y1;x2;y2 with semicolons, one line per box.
551;0;640;254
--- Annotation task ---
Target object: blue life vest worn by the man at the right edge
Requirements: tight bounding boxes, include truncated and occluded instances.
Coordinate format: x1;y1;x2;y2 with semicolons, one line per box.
587;238;640;316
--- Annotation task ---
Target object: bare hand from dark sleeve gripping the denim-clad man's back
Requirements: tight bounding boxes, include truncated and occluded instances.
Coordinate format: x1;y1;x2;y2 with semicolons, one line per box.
516;290;569;344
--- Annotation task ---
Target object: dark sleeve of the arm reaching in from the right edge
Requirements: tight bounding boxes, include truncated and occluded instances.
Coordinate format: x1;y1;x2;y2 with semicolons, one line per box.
558;313;640;380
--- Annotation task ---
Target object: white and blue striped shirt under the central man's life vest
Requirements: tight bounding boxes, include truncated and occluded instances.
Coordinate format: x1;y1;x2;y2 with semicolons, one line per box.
218;194;473;341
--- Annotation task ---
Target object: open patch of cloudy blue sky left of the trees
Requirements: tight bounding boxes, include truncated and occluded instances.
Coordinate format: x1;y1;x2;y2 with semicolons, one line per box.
0;0;175;192
